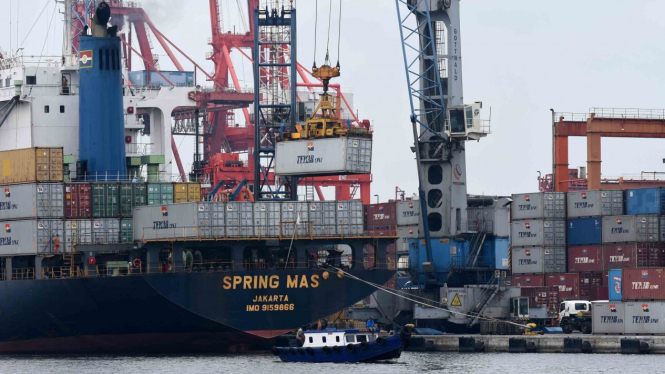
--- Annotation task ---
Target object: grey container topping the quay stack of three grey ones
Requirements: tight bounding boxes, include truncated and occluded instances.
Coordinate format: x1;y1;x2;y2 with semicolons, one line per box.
511;192;566;220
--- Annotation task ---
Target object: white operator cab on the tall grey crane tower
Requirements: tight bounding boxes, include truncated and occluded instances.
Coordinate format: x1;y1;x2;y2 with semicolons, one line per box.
446;102;490;140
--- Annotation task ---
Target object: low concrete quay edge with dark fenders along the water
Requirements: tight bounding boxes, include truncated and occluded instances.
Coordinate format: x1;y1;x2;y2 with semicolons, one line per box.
407;334;665;354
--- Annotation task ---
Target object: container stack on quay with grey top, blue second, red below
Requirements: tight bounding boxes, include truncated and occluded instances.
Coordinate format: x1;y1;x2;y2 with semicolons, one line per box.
567;190;624;300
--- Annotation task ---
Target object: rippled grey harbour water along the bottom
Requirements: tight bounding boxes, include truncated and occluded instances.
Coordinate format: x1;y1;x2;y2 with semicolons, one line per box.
0;352;665;374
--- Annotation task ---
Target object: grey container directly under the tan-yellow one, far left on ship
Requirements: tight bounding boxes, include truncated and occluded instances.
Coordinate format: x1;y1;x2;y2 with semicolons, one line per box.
0;183;65;220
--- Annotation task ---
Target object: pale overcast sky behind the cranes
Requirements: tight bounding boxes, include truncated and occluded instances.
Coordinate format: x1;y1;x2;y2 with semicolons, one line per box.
0;0;665;201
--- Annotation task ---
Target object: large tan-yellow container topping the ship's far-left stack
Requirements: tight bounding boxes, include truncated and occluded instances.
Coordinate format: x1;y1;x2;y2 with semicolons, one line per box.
0;147;63;185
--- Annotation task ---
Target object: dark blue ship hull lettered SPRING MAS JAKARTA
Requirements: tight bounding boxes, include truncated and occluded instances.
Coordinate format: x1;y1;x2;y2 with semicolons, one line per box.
0;269;394;353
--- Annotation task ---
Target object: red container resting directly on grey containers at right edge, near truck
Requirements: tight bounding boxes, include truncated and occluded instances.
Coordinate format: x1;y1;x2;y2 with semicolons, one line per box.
622;268;665;301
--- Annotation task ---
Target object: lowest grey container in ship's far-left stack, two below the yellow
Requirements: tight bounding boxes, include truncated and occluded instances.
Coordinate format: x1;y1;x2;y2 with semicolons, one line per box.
0;219;65;256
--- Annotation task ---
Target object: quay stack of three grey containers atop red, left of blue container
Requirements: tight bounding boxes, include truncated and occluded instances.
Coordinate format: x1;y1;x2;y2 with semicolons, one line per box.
510;192;564;300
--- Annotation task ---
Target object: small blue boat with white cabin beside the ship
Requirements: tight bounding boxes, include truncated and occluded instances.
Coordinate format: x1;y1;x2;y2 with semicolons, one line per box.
272;326;411;363
